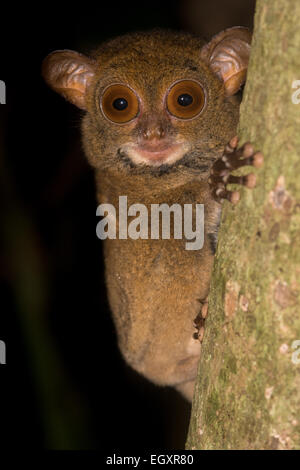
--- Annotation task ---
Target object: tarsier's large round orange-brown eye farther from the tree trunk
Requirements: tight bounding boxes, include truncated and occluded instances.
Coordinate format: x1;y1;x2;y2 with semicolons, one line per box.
101;84;139;124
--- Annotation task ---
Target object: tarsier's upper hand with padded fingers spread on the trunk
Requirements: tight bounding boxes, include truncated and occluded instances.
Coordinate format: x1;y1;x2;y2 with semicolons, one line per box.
208;136;264;204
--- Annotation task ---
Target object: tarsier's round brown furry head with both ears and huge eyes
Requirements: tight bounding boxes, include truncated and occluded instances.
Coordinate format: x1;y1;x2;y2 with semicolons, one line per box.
43;27;251;178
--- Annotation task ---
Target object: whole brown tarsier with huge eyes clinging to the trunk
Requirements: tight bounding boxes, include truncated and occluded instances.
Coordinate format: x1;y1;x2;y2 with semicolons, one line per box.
43;27;263;400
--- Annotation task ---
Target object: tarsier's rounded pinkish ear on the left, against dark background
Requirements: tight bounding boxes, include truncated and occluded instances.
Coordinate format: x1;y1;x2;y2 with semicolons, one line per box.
42;50;95;109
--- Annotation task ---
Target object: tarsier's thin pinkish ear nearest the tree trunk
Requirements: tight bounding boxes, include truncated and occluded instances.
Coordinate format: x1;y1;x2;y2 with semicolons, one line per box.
201;26;251;96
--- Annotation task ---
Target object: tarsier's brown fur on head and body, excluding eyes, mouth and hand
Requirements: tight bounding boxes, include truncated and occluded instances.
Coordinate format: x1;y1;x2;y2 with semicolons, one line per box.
40;28;249;399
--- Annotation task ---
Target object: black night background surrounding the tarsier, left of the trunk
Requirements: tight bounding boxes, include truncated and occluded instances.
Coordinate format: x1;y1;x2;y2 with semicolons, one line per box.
0;0;254;452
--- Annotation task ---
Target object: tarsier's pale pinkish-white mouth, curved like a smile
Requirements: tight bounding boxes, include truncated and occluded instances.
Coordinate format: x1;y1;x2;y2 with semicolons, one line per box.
120;142;190;167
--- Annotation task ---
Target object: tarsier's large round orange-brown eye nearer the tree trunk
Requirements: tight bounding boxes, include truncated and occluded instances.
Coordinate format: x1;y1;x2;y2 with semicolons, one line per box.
167;80;205;119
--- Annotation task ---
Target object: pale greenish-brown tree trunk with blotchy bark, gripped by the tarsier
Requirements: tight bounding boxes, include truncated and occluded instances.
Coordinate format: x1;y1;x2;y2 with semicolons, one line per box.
187;0;300;449
